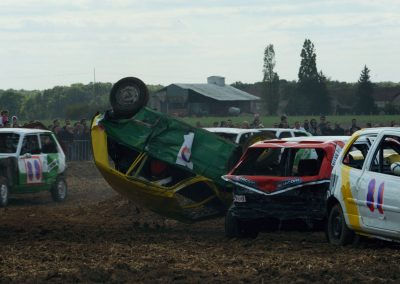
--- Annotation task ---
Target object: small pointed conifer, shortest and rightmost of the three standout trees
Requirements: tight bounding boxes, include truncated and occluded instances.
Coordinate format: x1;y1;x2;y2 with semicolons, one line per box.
354;65;377;114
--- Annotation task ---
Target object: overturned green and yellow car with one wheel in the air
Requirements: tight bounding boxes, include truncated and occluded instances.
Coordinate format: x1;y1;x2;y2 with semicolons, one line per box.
91;77;241;223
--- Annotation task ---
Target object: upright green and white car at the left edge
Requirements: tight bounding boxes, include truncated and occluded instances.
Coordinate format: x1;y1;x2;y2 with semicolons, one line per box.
0;128;67;207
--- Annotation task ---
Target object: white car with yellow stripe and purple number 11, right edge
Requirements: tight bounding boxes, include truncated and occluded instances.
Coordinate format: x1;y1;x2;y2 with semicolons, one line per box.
326;128;400;245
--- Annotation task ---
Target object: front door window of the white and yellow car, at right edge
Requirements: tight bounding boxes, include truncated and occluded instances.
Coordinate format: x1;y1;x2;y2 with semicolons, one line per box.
369;135;400;175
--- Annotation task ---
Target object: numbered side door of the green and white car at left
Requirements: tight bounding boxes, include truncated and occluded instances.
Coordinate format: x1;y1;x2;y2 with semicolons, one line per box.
18;134;44;191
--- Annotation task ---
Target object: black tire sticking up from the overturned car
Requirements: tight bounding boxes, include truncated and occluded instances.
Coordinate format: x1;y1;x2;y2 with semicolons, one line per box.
110;77;149;119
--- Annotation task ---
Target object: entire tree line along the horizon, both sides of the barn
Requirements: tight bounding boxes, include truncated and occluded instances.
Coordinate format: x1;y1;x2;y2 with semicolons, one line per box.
0;39;400;120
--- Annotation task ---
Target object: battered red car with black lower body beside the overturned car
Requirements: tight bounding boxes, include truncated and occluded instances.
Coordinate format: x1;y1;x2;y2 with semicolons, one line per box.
223;137;348;237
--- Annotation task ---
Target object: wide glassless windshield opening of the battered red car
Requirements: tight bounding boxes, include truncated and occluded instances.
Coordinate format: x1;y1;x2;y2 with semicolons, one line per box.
233;148;325;177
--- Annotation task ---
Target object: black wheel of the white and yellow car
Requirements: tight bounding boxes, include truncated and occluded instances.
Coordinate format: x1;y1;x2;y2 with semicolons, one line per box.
326;204;354;246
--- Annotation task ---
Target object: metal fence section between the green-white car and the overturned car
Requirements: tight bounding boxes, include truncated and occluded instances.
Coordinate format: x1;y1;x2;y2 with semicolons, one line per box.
60;140;93;161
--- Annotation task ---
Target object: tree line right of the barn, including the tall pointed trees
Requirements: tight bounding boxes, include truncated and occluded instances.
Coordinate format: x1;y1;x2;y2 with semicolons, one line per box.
233;39;400;115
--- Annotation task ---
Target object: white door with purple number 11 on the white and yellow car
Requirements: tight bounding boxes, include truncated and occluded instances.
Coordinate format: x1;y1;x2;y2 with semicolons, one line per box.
357;132;400;236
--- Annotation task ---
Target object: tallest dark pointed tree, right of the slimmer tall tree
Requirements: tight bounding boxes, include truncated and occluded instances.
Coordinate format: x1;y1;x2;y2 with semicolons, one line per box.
287;39;331;114
